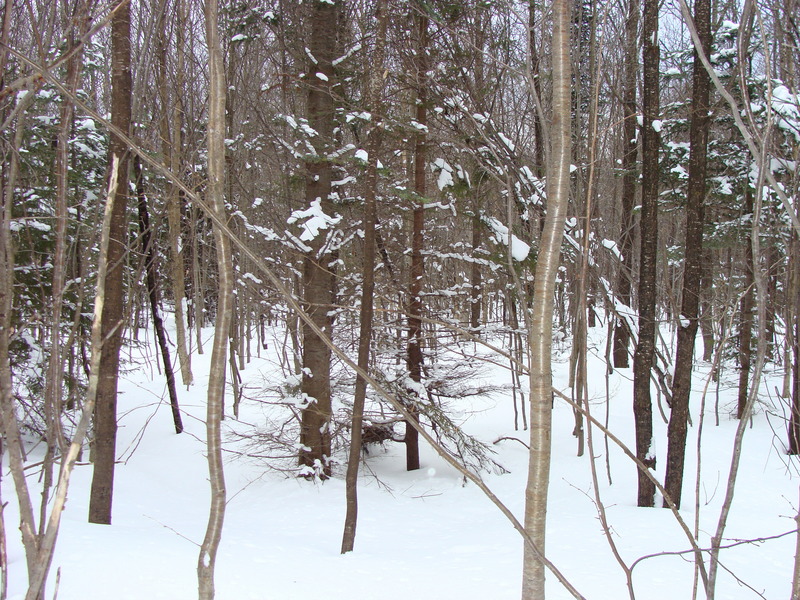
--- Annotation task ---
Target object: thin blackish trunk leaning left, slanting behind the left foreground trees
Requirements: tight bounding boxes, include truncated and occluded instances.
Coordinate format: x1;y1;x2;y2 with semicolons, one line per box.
133;156;183;433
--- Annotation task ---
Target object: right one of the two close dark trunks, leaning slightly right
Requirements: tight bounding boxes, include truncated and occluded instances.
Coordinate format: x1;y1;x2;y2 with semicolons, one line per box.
664;0;711;507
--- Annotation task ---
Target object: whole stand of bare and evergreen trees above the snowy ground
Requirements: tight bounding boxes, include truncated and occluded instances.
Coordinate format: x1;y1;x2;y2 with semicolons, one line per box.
0;0;800;600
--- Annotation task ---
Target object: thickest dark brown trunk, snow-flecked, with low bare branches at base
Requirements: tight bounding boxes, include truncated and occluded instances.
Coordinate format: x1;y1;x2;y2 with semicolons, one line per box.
300;0;341;477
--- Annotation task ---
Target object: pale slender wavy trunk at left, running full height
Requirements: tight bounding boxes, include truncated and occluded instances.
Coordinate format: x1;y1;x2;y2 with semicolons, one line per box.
197;0;228;600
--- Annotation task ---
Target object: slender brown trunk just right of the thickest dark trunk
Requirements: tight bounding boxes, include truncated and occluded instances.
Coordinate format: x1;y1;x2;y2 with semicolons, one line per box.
342;0;387;554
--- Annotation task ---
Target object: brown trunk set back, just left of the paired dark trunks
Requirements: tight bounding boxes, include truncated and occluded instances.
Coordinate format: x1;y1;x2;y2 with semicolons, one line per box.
614;0;640;369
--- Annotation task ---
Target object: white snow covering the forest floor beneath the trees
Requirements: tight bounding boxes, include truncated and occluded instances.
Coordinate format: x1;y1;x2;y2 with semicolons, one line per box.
3;316;800;600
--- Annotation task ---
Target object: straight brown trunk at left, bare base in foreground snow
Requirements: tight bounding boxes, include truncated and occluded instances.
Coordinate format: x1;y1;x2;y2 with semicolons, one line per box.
89;0;131;525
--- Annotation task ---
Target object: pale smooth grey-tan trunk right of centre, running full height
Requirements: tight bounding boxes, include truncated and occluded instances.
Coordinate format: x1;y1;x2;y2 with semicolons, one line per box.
522;0;571;600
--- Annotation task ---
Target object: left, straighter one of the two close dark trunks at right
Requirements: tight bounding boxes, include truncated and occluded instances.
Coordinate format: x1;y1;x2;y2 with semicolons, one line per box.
633;0;661;506
